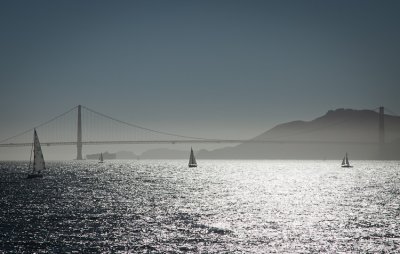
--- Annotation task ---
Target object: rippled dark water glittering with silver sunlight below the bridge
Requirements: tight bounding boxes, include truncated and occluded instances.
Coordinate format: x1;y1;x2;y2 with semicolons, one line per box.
0;161;400;253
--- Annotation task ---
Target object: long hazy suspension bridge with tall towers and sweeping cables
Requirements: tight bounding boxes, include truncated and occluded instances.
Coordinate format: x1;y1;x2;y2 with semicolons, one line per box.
0;105;392;160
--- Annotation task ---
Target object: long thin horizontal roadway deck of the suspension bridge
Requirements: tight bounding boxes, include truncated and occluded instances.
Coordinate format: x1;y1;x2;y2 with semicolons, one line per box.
0;139;378;147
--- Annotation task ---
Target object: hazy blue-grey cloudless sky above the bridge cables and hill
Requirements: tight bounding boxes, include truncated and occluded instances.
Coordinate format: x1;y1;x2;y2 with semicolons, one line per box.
0;0;400;147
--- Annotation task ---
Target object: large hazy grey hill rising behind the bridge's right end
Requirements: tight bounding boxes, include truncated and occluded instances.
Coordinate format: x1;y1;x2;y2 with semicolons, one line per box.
197;109;400;159
